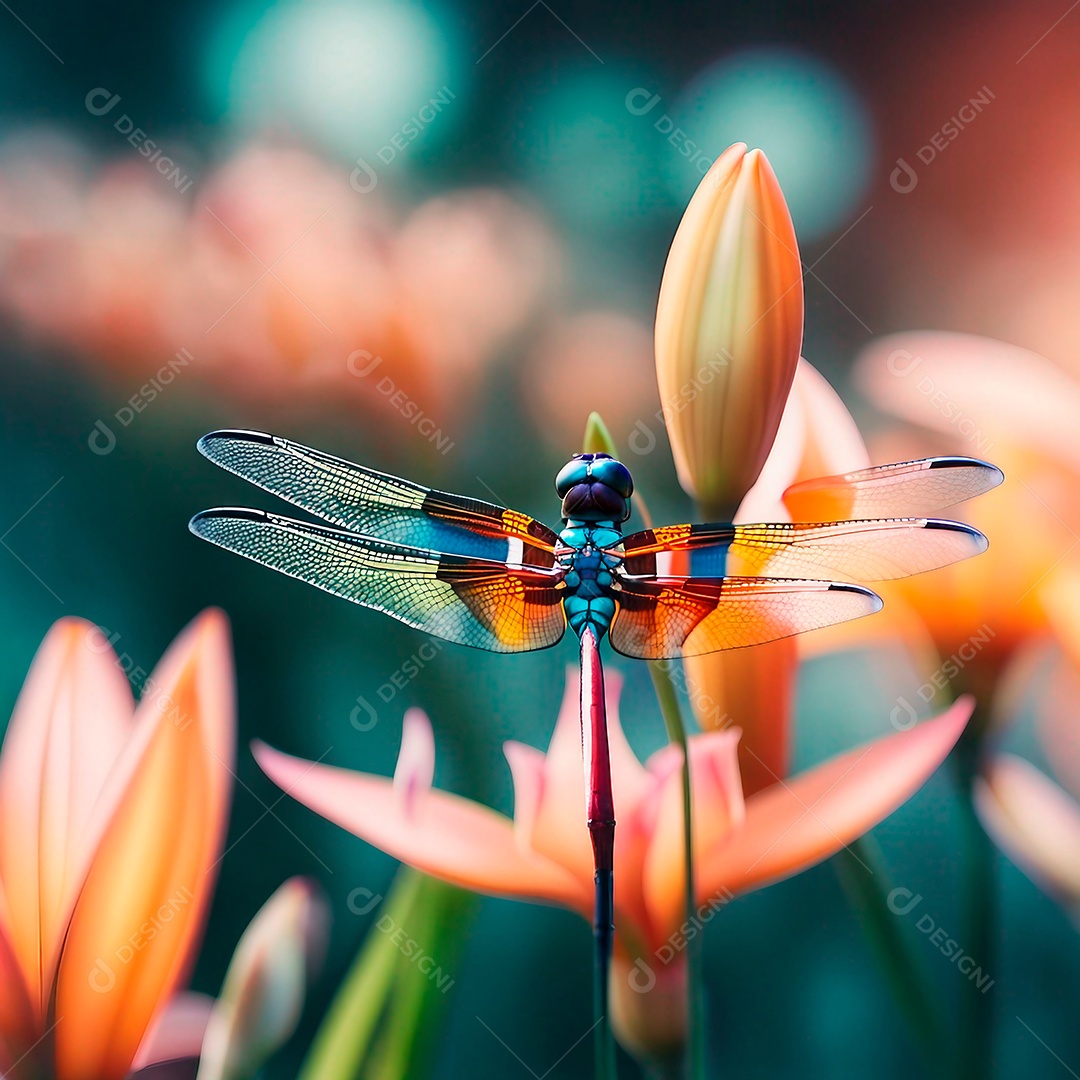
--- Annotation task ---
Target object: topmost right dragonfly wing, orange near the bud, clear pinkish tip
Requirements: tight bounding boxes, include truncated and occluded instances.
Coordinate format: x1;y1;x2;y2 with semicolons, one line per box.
784;457;1004;522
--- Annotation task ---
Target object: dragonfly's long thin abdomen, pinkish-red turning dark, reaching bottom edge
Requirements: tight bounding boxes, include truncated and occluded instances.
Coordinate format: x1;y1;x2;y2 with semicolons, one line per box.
581;626;615;1080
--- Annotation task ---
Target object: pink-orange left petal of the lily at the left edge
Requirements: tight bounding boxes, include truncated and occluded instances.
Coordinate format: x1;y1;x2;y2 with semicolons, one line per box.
0;619;134;1017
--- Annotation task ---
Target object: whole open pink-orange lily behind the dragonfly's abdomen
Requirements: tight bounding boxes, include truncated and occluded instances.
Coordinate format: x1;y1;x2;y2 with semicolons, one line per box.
254;671;971;1053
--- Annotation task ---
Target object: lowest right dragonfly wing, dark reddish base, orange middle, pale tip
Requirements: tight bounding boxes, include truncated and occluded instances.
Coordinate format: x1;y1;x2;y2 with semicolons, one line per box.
610;578;881;660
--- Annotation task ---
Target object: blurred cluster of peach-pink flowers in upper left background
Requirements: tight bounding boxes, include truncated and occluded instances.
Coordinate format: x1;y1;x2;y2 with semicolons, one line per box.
0;146;556;425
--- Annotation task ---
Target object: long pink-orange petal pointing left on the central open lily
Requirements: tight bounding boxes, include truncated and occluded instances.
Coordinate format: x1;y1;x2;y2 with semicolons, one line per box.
252;714;589;910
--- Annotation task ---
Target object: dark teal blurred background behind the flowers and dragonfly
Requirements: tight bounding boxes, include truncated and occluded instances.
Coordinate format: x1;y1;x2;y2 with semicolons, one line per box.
0;0;1080;1080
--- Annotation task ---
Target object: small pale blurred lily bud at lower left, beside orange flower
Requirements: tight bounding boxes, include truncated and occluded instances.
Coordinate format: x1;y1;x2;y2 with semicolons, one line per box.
198;878;328;1080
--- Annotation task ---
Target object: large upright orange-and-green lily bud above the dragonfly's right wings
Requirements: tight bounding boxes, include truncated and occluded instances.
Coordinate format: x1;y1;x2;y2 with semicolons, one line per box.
656;143;802;519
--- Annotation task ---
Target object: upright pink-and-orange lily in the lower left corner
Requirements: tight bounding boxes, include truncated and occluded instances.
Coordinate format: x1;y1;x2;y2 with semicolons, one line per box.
0;611;234;1080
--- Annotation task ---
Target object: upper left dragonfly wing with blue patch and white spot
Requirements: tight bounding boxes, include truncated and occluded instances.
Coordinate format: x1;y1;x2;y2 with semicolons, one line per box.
199;431;558;567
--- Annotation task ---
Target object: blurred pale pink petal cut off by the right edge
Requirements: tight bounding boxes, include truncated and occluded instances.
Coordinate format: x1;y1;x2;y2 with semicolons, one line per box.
975;754;1080;910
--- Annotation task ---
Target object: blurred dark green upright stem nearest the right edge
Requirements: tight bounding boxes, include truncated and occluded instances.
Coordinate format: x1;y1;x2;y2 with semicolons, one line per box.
951;721;997;1080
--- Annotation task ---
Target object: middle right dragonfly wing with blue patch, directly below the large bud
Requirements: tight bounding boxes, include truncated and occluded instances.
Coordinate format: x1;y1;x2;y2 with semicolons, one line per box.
622;517;987;581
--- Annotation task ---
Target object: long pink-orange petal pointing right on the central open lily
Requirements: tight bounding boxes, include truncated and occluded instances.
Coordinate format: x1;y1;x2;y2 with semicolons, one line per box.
698;698;974;901
